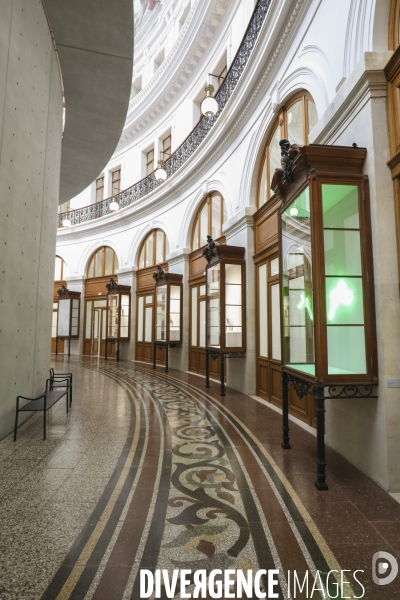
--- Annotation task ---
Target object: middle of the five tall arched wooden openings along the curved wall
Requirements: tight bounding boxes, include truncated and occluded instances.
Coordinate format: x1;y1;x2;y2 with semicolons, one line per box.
136;229;169;364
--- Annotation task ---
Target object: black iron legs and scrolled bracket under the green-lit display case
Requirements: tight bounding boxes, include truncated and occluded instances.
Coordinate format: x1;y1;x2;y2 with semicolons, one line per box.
281;370;378;491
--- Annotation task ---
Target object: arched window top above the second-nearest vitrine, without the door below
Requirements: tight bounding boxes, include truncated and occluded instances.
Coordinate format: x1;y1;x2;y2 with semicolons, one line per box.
192;192;228;250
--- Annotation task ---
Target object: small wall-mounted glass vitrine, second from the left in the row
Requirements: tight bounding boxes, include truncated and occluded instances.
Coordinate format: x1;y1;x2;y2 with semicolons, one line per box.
106;278;131;341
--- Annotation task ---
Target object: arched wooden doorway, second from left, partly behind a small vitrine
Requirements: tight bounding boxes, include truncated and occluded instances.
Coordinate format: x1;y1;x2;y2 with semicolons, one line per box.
83;246;119;357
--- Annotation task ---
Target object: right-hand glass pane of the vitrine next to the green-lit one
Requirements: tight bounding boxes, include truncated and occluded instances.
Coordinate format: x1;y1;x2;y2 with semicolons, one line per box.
225;264;243;348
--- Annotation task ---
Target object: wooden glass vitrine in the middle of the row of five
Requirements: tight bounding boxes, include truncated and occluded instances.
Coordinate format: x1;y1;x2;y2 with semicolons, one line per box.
153;266;183;345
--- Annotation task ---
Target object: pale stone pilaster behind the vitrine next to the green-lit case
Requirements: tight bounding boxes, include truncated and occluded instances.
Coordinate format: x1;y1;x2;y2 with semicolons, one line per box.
222;206;256;394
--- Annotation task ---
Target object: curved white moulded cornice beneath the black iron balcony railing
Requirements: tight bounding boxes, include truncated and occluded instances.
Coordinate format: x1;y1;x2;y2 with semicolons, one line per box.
57;0;312;242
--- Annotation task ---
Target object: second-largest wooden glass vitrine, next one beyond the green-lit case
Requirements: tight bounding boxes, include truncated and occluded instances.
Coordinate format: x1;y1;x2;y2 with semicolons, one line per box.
204;238;246;353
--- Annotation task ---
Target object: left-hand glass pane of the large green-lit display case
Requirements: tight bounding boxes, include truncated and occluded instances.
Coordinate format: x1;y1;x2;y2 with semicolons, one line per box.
282;188;315;374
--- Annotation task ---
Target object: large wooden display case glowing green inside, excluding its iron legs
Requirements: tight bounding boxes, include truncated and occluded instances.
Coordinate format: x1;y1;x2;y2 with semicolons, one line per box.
272;145;378;386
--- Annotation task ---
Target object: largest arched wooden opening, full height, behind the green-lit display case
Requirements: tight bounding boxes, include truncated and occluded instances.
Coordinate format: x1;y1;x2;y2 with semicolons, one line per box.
254;91;318;425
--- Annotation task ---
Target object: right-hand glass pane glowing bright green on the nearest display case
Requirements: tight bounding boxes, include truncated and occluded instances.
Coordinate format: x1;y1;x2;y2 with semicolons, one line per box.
322;184;366;375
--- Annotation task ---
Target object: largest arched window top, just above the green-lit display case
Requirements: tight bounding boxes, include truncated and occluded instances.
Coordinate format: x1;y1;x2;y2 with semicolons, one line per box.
257;92;318;208
